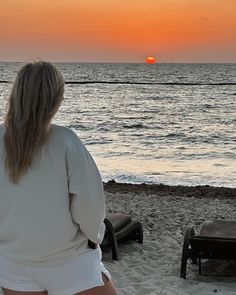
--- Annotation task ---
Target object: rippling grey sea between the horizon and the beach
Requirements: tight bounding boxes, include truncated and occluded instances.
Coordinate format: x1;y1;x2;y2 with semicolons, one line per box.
0;63;236;187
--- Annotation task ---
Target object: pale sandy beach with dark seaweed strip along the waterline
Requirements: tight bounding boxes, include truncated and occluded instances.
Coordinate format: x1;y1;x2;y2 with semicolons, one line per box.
103;181;236;295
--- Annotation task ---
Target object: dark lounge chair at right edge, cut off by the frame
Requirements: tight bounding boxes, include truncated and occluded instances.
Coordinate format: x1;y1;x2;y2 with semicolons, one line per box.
180;219;236;279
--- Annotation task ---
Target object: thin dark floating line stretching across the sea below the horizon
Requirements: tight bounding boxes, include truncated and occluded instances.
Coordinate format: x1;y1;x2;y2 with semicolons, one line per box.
0;80;236;86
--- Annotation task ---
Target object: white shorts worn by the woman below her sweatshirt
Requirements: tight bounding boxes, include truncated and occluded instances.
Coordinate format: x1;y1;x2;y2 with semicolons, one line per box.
0;248;111;295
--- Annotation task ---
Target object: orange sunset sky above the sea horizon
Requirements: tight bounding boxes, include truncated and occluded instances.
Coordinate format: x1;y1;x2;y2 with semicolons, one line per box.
0;0;236;63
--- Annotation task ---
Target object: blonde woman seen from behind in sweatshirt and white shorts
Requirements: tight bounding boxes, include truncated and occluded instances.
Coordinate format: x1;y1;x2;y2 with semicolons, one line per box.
0;61;117;295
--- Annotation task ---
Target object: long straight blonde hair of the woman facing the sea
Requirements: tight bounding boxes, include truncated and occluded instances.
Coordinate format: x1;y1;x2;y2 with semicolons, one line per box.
4;61;64;184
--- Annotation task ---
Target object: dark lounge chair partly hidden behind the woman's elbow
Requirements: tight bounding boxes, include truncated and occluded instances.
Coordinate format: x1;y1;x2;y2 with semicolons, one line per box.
88;213;143;260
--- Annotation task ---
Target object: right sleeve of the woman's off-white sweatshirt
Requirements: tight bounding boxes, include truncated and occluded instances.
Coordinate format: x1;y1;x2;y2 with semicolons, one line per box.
66;134;105;244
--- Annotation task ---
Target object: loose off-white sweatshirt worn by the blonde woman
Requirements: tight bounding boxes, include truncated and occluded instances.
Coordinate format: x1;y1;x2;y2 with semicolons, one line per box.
0;125;105;265
